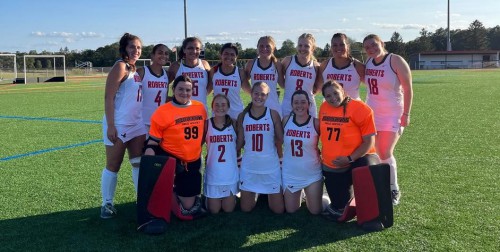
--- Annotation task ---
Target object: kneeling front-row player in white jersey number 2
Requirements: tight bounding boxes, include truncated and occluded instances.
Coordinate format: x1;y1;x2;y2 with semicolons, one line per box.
203;94;239;214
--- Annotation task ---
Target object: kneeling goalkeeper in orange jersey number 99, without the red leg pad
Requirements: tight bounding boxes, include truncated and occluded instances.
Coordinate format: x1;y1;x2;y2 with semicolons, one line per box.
144;75;207;217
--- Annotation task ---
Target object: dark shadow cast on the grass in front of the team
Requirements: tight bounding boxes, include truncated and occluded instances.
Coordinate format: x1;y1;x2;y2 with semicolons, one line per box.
0;202;365;251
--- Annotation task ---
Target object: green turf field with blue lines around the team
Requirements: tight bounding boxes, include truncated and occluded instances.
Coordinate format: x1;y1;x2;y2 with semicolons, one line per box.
0;70;500;251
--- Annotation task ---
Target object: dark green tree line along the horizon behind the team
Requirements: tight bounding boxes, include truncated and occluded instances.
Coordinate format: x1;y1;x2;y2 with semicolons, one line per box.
0;20;500;69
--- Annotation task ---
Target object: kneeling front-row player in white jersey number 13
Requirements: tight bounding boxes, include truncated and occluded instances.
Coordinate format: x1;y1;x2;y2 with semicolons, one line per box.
282;90;323;214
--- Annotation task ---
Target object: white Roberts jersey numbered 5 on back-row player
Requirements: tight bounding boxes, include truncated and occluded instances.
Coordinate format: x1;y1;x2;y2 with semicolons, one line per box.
175;59;208;111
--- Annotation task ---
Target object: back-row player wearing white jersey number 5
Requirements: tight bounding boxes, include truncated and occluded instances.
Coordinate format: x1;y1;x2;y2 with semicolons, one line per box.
168;37;210;111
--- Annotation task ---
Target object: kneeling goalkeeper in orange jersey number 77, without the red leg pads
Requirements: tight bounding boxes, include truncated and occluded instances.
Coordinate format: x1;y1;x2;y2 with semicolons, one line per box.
319;80;379;219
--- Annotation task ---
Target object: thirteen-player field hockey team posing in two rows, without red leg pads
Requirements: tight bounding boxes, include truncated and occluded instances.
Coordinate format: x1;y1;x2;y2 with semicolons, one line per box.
101;30;413;223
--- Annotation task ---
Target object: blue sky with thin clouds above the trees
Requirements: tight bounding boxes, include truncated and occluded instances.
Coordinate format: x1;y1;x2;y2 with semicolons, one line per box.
0;0;500;53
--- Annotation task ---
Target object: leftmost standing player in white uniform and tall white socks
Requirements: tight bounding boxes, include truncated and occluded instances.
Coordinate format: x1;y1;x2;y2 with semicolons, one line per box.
101;33;146;219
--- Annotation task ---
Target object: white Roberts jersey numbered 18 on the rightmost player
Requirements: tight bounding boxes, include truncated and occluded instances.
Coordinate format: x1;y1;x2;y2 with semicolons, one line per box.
365;54;403;116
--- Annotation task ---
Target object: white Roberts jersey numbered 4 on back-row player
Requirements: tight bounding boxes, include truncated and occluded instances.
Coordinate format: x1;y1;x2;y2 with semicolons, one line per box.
142;66;169;125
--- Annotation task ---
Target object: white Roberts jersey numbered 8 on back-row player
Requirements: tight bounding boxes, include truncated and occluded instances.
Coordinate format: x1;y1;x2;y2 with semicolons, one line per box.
281;56;317;117
